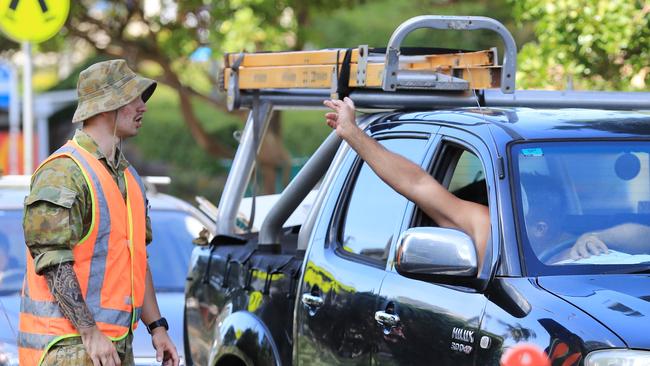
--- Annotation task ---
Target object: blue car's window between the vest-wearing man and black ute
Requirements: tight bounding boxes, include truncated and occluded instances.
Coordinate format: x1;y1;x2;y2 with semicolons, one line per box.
147;209;203;291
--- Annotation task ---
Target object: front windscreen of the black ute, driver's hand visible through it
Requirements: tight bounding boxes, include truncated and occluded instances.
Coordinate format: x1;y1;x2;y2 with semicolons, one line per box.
511;141;650;266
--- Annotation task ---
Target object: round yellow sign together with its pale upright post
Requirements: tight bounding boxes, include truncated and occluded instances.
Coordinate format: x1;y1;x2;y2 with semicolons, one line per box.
0;0;70;174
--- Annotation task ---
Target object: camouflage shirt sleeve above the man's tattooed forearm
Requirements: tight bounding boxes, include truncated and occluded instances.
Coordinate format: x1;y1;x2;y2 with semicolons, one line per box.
23;157;88;274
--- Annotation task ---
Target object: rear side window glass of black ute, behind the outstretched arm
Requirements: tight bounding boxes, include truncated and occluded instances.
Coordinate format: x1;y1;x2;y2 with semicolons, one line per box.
339;138;427;263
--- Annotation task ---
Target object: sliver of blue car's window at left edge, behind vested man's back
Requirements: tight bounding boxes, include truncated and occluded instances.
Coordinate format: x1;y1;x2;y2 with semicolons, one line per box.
0;210;27;293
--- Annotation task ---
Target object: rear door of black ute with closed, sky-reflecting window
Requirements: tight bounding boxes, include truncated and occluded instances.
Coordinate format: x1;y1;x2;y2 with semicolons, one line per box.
295;124;438;365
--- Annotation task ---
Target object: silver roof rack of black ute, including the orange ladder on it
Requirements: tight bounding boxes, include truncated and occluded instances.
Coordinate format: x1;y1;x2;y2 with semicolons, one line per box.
217;15;650;237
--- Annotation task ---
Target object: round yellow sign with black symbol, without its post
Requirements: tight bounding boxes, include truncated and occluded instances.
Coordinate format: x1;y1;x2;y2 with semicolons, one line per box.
0;0;70;43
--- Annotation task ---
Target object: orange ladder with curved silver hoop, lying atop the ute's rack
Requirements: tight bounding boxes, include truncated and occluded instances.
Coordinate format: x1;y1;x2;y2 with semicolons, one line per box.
221;15;517;110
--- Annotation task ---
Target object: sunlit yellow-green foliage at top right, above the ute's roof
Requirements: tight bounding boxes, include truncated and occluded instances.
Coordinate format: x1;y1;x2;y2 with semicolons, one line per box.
510;0;650;90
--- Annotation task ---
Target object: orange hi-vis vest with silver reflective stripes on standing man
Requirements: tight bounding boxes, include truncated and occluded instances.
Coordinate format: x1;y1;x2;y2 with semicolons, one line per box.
18;141;147;366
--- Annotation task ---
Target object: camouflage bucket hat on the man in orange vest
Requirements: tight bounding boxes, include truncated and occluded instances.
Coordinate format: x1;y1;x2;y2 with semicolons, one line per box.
72;60;157;123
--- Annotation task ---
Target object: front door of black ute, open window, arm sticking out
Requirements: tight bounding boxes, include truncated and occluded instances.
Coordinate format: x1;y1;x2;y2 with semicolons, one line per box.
374;128;497;365
